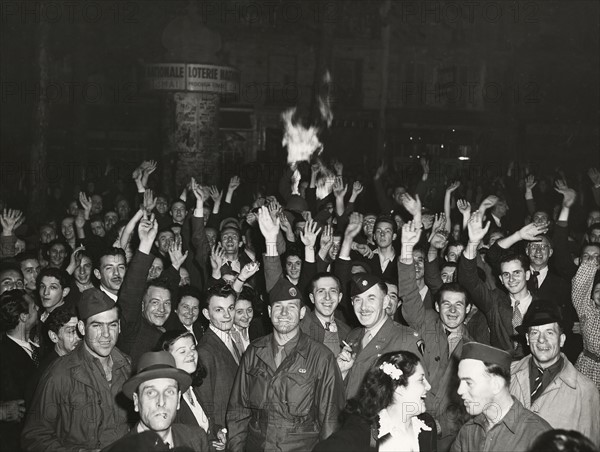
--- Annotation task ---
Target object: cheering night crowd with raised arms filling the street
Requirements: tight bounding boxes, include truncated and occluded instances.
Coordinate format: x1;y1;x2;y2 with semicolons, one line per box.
0;159;600;452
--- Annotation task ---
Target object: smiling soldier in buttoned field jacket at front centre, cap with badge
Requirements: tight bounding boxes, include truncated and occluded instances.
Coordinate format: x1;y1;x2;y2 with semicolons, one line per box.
227;278;344;452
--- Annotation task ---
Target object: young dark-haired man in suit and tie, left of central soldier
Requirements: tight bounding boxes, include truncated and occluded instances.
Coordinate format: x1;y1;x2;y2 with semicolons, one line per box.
198;283;241;427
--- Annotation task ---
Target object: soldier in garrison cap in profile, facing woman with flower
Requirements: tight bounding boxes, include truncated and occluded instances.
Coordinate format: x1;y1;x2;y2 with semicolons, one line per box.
450;342;551;452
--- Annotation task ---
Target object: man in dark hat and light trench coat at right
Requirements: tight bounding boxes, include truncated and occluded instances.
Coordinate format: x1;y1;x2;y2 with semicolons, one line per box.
510;300;600;446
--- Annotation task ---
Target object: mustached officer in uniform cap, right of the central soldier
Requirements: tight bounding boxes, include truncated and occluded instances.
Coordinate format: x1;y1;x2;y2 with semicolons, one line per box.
337;267;423;399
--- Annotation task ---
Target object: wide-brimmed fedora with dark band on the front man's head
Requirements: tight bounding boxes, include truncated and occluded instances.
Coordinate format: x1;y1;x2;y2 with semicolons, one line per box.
123;352;192;399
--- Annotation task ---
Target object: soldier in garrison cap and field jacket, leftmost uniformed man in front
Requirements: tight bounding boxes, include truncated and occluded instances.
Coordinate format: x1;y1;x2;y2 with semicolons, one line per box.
22;289;131;451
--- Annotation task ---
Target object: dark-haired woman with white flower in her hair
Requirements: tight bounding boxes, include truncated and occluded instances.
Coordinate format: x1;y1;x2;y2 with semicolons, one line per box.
313;351;437;452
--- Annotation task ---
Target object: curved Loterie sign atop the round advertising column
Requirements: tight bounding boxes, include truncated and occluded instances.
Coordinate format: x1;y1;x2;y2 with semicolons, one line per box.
144;63;240;94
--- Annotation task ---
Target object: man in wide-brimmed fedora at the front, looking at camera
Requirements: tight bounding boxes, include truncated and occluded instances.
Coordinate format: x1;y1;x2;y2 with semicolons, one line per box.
119;351;209;451
